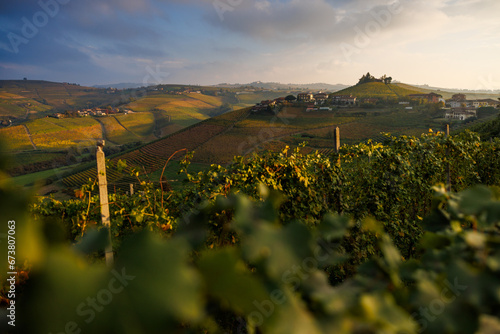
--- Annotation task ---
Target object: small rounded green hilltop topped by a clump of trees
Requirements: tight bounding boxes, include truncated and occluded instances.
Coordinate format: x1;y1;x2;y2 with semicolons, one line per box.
334;82;422;98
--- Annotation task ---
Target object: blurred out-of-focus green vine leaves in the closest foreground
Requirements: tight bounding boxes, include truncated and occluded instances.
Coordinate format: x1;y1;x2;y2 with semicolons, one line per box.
2;172;500;333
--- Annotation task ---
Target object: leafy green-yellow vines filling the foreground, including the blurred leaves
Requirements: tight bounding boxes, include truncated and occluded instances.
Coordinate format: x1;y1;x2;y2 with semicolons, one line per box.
0;132;500;334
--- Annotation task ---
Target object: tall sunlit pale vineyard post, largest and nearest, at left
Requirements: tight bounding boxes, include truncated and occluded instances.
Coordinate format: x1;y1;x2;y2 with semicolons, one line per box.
97;140;113;267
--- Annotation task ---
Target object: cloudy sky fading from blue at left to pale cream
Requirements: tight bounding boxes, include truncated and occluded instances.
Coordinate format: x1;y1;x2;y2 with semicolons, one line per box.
0;0;500;90
